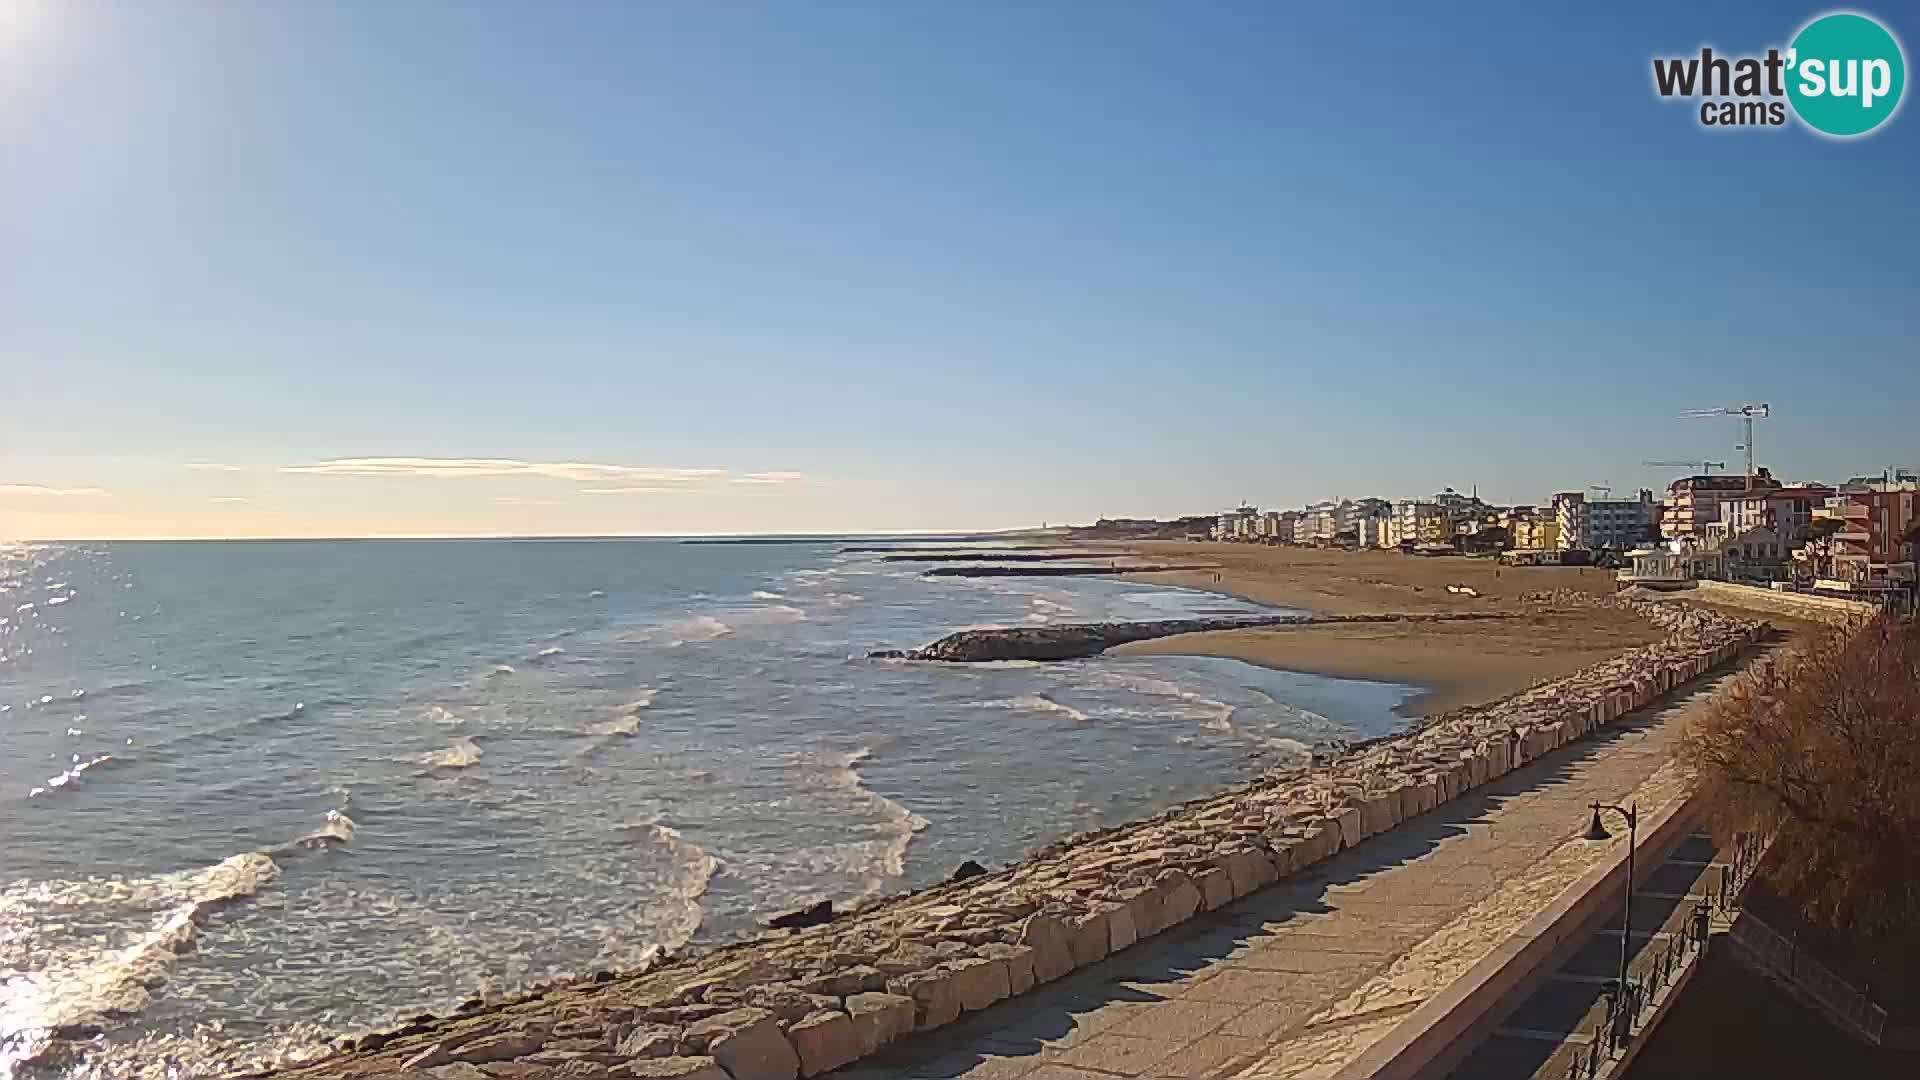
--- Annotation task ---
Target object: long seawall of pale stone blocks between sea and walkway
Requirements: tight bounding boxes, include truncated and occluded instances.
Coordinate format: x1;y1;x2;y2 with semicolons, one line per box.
259;601;1766;1080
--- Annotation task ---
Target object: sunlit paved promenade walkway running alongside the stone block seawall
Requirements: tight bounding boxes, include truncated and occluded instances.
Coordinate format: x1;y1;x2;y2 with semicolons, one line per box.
835;680;1743;1080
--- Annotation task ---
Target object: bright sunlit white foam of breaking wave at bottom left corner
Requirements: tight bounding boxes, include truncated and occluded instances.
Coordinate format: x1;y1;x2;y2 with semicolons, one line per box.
0;851;280;1076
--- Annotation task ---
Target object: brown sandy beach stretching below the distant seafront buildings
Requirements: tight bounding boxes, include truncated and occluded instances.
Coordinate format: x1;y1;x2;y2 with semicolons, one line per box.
1114;542;1659;715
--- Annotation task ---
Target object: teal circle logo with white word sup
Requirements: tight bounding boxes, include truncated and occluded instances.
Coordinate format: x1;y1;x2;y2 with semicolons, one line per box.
1788;12;1907;138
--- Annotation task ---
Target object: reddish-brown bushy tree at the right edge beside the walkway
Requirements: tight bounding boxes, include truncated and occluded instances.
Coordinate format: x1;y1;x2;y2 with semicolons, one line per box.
1682;617;1920;959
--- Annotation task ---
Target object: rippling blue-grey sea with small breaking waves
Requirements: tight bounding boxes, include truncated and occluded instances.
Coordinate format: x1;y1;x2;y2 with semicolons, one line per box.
0;538;1415;1080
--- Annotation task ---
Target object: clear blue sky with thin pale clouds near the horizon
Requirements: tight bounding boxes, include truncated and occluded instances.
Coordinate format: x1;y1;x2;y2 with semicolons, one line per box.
0;0;1920;540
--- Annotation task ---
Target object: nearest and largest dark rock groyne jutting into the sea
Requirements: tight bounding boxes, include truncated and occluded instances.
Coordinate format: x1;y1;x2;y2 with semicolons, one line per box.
868;611;1519;663
